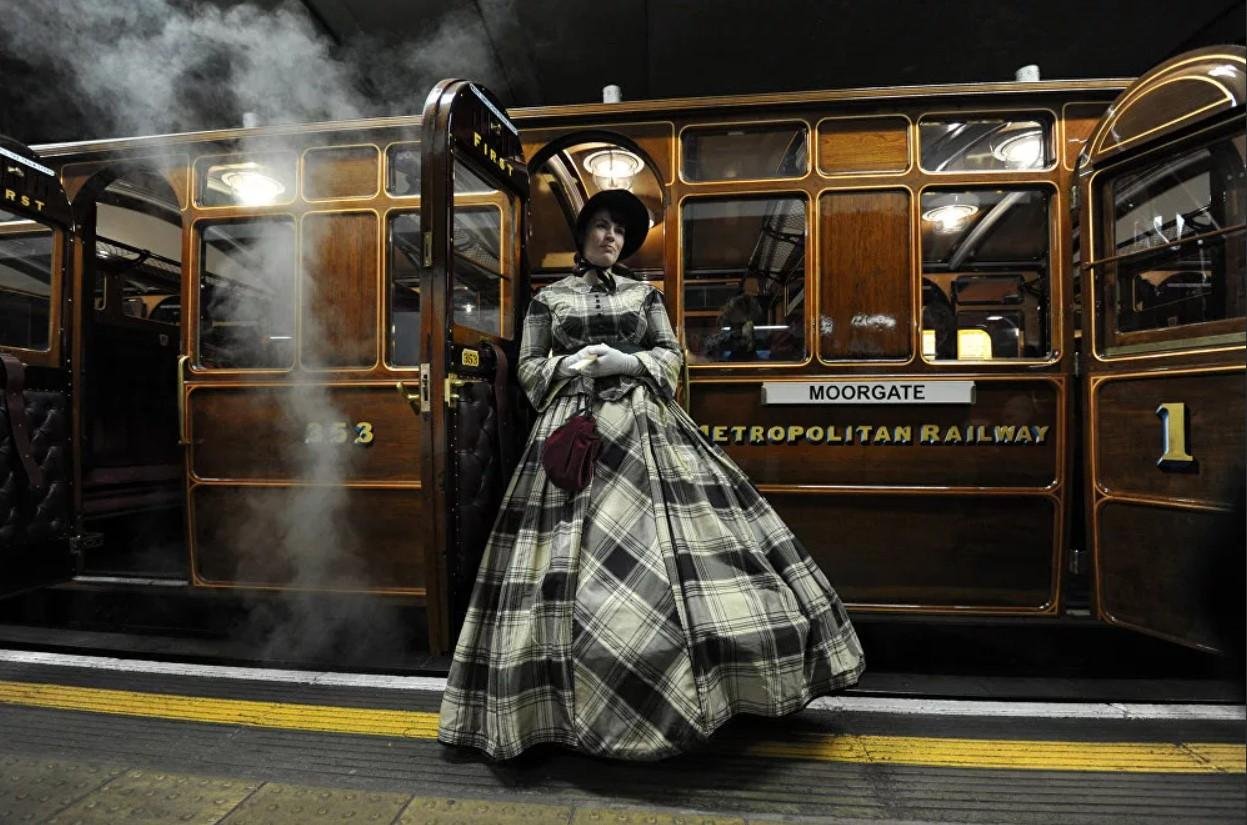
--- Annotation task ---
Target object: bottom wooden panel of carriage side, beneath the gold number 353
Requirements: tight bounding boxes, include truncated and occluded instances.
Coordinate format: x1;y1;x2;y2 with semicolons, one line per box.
191;485;428;591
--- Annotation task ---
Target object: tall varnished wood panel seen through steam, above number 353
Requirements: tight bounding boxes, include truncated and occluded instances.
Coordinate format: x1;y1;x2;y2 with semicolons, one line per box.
299;212;379;368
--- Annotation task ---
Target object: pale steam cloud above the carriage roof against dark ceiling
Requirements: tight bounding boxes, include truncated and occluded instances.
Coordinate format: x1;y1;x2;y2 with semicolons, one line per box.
0;0;510;137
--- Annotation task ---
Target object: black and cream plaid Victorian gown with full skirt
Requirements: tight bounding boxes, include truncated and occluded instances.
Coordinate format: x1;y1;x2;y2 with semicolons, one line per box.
438;275;864;759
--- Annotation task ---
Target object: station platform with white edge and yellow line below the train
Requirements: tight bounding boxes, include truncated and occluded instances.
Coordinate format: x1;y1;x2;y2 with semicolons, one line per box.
0;651;1247;825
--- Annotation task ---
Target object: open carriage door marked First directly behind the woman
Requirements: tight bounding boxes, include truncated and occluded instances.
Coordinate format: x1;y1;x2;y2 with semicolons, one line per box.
420;81;527;651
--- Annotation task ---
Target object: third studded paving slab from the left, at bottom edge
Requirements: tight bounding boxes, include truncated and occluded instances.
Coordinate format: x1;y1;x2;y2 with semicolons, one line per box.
221;783;410;825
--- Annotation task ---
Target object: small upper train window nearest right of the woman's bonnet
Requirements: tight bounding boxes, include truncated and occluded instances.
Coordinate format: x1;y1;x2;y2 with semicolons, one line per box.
680;123;809;182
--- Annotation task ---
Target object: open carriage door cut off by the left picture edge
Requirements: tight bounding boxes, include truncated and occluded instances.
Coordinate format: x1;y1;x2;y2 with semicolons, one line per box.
0;137;74;596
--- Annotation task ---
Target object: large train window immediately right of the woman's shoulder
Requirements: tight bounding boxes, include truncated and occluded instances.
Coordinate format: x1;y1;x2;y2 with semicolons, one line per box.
681;196;808;364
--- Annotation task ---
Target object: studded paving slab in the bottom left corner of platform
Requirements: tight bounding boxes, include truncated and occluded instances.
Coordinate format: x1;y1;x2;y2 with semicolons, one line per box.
0;756;121;825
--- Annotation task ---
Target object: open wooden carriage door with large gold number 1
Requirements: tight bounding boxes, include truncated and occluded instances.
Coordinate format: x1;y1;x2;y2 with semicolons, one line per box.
1077;47;1247;652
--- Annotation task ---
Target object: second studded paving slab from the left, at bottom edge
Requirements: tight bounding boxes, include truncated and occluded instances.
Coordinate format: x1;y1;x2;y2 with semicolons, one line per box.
49;770;259;825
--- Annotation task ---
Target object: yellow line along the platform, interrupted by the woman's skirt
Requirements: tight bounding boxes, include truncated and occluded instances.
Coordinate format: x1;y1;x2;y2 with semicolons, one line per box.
0;680;1247;774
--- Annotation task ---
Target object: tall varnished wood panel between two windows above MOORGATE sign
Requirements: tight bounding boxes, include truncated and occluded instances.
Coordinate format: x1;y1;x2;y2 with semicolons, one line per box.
819;189;913;360
